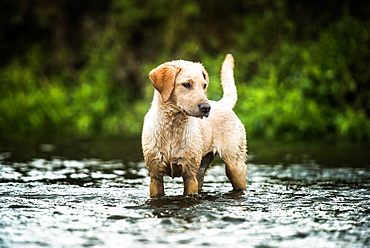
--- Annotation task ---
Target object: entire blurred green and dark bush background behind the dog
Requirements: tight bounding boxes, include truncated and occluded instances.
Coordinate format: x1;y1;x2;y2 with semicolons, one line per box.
0;0;370;141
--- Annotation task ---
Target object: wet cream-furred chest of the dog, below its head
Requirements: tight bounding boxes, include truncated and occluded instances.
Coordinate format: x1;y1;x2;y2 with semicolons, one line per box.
142;106;203;176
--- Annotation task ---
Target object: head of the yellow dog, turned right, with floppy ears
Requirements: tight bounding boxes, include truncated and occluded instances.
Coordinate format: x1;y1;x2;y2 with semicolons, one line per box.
149;60;211;118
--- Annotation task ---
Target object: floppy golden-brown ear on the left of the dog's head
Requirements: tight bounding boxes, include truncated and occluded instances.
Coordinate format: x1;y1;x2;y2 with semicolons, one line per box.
149;63;180;102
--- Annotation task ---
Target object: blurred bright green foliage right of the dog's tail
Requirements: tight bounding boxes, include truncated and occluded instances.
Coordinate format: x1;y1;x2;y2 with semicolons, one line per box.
228;8;370;141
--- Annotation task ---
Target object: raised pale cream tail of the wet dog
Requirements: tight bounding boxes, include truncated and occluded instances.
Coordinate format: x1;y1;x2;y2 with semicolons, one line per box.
220;54;238;108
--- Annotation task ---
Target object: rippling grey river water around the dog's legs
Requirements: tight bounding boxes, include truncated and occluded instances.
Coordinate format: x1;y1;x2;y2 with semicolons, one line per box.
0;140;370;248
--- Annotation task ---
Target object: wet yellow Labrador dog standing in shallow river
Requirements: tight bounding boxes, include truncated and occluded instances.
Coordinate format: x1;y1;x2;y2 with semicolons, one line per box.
142;54;247;198
